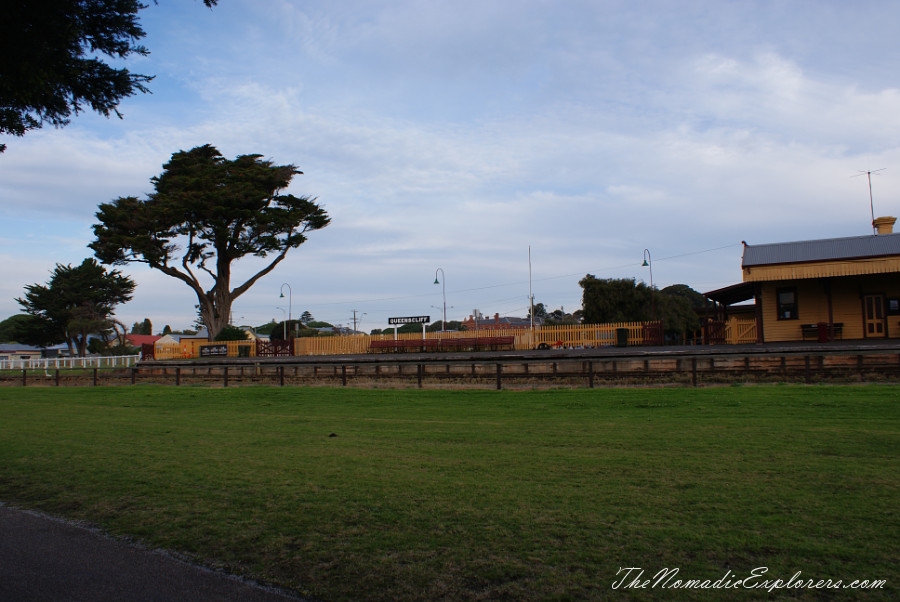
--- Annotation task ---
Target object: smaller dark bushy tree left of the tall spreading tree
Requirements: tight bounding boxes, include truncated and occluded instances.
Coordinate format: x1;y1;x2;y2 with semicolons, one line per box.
16;259;135;356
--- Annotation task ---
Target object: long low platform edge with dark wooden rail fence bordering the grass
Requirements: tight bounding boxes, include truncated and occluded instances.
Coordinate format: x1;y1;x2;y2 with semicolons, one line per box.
10;348;900;389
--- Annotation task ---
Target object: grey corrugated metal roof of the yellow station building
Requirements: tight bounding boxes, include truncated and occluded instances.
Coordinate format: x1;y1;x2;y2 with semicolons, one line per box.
741;233;900;268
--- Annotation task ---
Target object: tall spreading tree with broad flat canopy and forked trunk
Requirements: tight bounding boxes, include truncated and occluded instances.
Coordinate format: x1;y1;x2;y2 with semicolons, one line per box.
89;145;330;338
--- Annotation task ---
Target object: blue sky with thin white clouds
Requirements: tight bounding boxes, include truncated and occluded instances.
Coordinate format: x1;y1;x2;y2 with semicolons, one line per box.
0;0;900;332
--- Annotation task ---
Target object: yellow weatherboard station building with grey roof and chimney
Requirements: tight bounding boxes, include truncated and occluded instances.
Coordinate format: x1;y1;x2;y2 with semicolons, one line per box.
704;217;900;343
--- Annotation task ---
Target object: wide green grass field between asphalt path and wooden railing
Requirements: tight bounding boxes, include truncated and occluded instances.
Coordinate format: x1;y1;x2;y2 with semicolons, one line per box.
0;385;900;601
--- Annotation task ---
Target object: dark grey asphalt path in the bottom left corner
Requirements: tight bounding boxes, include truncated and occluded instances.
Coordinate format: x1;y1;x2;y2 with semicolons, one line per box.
0;505;302;602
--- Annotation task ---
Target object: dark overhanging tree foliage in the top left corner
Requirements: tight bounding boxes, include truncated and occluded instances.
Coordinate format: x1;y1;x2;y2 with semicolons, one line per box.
0;0;218;152
